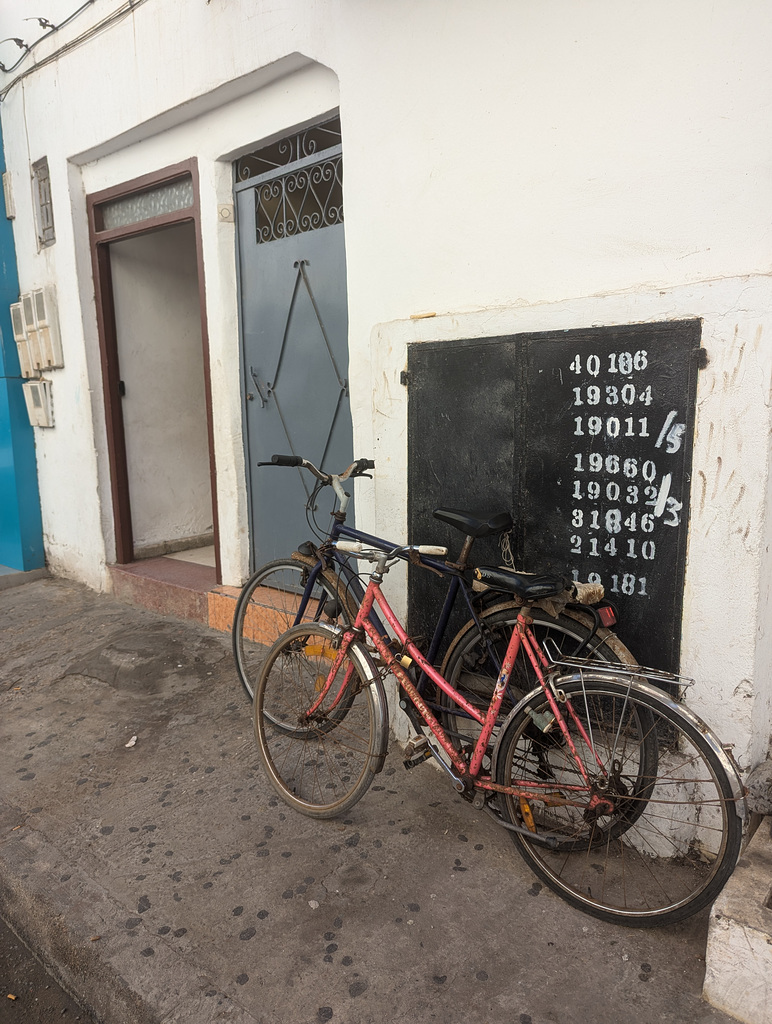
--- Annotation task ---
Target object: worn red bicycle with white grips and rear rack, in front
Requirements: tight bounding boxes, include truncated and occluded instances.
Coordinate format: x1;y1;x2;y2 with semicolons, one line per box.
254;541;745;926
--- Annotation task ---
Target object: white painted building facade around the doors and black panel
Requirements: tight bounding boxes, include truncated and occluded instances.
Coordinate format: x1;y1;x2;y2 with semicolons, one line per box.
0;0;772;767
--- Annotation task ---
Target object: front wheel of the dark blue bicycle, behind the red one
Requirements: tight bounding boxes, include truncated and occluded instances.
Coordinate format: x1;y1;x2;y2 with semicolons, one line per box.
231;553;356;700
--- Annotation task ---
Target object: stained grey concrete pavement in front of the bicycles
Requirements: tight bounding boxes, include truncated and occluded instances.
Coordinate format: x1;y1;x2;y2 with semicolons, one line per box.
0;579;732;1024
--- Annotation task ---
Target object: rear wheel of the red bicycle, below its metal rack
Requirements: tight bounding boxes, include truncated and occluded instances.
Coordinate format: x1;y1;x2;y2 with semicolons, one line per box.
495;674;742;927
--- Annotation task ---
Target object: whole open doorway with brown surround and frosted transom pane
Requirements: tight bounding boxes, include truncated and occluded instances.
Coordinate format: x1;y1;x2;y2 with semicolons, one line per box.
88;164;220;581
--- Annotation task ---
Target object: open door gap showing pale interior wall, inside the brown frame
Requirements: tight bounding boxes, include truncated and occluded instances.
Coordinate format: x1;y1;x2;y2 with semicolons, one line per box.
110;221;213;559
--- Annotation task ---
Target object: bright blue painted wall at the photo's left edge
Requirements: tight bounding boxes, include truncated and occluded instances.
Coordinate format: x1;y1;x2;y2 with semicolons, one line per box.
0;120;45;571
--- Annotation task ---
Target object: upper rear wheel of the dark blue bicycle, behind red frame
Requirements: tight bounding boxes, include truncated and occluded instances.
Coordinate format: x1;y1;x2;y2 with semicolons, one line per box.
437;601;638;750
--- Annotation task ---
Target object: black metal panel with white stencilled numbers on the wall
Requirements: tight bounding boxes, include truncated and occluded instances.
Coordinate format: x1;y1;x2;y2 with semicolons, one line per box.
409;321;700;672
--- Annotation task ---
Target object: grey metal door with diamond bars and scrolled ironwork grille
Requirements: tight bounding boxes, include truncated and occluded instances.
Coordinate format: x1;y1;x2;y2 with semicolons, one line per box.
235;126;353;566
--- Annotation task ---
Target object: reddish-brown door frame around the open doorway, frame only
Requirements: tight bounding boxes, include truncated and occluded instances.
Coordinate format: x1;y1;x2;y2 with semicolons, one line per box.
86;159;222;583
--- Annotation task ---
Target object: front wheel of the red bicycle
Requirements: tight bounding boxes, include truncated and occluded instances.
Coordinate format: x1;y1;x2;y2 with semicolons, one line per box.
254;623;388;818
